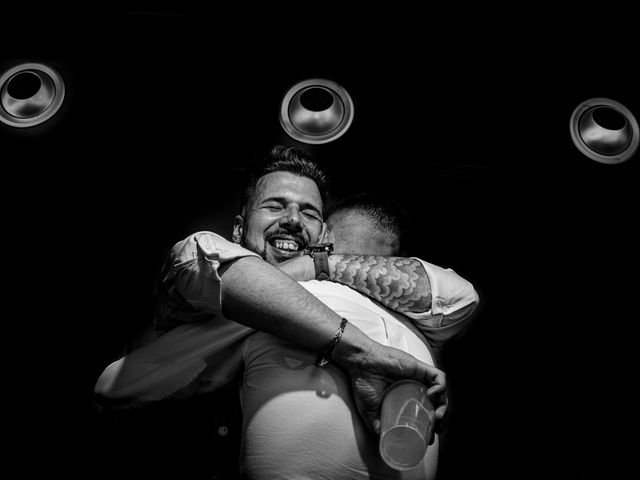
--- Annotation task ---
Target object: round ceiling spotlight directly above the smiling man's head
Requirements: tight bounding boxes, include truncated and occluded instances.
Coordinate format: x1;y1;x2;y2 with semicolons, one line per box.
280;78;353;144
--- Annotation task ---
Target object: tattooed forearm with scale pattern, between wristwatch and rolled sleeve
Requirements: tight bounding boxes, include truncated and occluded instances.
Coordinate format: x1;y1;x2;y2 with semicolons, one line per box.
329;255;431;313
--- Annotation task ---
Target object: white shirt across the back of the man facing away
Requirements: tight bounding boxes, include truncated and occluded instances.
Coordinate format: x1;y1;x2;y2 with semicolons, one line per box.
241;280;438;480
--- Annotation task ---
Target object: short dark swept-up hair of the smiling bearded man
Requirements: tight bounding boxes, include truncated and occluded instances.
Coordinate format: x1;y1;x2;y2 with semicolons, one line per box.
241;145;329;214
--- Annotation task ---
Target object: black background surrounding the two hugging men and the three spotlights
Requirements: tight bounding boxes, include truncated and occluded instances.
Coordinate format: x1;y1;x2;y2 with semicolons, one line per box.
0;2;640;479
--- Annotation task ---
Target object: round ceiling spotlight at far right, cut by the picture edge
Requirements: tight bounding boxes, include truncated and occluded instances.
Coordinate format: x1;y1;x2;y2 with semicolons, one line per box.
570;98;640;164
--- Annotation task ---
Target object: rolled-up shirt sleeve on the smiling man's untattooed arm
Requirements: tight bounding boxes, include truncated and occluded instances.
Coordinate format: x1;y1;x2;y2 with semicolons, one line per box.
155;231;259;333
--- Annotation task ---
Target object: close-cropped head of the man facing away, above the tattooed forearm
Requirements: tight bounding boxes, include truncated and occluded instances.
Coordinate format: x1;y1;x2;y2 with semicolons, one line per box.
327;192;409;256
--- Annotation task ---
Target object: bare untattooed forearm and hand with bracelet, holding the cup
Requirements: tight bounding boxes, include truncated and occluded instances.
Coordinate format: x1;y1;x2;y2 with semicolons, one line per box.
222;257;447;433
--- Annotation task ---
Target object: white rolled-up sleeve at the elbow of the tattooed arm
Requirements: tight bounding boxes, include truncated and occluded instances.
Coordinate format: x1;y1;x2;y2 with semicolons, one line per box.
405;258;480;347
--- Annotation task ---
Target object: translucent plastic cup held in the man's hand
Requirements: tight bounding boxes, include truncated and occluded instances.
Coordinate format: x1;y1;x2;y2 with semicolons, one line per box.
379;380;435;470
